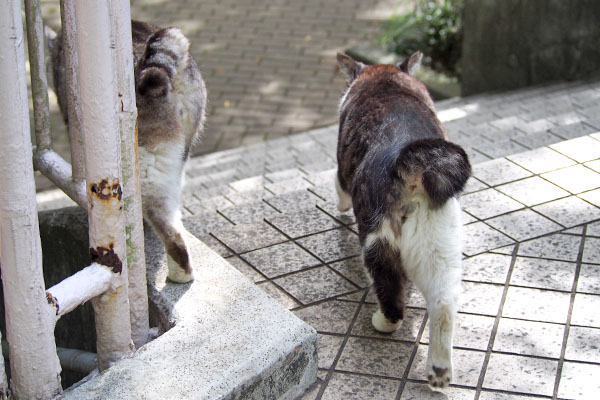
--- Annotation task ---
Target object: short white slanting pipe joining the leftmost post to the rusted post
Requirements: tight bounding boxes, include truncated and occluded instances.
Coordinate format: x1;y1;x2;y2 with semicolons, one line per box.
46;263;115;318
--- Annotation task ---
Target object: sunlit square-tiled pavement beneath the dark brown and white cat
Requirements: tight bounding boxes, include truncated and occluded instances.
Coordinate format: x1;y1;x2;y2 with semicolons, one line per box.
169;78;600;400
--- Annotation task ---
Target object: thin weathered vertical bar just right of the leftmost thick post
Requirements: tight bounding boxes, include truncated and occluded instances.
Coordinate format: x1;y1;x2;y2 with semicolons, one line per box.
25;0;52;150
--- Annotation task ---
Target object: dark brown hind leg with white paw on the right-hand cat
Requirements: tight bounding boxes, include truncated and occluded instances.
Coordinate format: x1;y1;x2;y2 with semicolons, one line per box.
364;239;406;333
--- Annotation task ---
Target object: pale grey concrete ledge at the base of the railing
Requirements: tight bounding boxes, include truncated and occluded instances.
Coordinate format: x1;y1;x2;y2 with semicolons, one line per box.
63;229;317;400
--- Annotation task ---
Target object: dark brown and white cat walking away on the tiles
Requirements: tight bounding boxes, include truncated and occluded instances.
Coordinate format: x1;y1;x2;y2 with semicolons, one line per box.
336;53;471;387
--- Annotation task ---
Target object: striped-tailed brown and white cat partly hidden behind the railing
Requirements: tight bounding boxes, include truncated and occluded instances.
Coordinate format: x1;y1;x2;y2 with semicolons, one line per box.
47;21;206;283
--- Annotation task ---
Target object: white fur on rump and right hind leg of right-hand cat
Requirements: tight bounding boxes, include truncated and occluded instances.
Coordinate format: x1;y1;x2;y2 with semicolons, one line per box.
365;195;462;388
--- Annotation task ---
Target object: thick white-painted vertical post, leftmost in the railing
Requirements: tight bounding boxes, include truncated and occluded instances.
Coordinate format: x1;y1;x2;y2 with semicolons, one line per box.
0;0;61;399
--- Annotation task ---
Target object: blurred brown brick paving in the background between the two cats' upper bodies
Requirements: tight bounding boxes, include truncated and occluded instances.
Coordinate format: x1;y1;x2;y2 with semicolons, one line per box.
42;0;410;154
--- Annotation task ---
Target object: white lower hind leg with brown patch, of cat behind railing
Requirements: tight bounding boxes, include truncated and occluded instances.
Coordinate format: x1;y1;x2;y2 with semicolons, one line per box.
144;198;194;283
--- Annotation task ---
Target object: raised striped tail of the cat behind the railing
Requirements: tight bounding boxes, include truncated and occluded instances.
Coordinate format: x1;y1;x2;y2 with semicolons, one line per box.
136;28;190;97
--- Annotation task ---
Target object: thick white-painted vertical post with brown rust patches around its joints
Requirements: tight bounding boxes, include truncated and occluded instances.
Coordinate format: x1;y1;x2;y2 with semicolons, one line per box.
75;0;133;371
